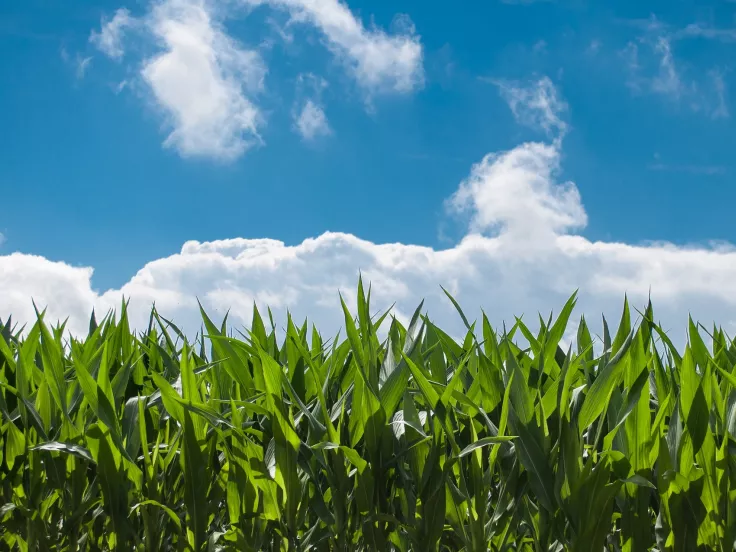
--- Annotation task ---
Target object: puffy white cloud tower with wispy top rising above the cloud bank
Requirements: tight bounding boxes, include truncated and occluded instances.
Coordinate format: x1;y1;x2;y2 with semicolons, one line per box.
448;77;587;244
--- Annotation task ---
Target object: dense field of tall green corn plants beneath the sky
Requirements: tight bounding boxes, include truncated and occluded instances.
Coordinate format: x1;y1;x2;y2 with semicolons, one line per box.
0;282;736;552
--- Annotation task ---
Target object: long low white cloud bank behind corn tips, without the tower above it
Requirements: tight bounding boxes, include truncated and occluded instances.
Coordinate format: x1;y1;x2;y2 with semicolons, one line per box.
0;194;736;348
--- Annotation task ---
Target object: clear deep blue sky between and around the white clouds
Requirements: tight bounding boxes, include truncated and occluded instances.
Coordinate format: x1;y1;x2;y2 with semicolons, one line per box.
0;0;736;288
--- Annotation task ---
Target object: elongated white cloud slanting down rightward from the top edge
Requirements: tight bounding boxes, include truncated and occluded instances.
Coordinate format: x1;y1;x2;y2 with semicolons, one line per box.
242;0;424;94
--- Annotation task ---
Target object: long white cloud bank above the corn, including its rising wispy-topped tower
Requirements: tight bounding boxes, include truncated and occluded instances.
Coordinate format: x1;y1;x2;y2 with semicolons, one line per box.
0;76;736;348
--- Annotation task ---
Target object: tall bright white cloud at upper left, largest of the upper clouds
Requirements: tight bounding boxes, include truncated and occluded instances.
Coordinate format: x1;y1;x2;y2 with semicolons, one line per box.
141;0;266;160
